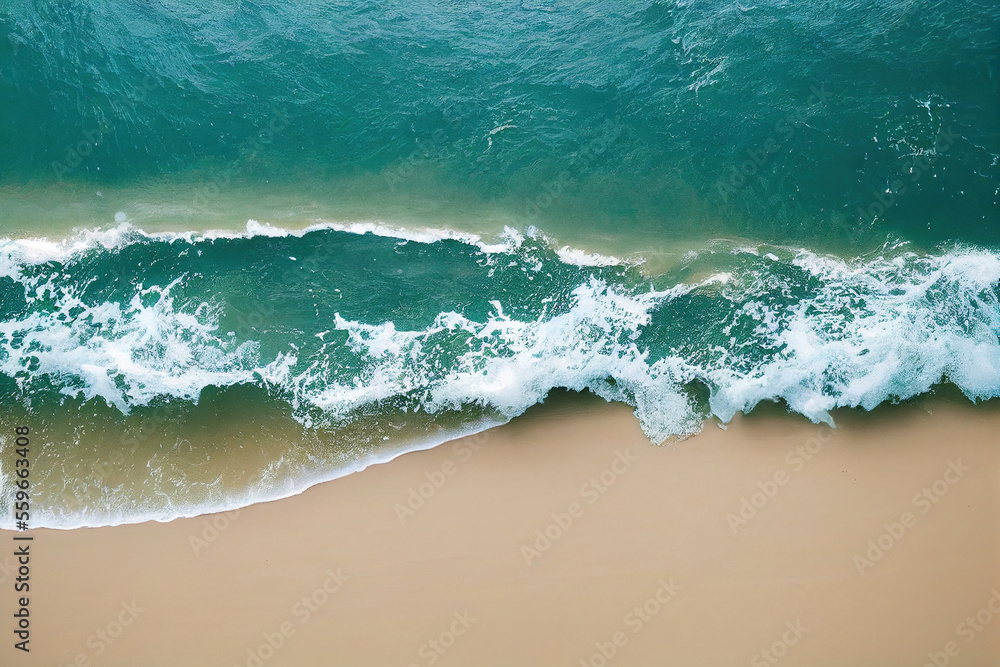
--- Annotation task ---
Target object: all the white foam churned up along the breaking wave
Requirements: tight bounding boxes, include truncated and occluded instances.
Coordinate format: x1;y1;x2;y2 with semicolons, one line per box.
0;227;1000;527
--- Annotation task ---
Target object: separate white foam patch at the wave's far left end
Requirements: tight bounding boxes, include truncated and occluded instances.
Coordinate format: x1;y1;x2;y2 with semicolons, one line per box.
0;279;274;412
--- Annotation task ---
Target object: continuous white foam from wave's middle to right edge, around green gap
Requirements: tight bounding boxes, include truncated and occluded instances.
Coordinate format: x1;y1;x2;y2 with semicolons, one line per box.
292;245;1000;441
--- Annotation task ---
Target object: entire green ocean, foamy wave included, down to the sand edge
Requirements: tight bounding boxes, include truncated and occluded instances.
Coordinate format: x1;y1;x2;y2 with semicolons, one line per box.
0;0;1000;528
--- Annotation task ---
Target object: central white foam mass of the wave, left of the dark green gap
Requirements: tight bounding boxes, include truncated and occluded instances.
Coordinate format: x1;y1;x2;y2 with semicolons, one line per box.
328;278;700;441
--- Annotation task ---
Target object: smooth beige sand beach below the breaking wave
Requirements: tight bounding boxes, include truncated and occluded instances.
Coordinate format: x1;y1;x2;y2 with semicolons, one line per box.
0;400;1000;667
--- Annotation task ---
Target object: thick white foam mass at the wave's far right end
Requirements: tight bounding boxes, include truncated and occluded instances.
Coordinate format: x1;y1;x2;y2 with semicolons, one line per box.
707;245;1000;423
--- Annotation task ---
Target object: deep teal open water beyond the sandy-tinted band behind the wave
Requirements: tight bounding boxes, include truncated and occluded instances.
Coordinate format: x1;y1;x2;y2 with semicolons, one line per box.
0;0;1000;247
